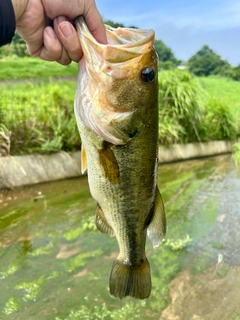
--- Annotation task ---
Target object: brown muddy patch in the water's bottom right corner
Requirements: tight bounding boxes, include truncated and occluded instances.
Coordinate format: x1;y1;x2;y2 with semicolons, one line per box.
160;266;240;320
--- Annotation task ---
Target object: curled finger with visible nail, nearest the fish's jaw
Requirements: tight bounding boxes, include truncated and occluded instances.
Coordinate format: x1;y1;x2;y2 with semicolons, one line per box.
54;16;83;62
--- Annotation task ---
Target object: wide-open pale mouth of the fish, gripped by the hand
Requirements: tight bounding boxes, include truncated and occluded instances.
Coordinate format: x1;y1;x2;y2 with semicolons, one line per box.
75;16;155;63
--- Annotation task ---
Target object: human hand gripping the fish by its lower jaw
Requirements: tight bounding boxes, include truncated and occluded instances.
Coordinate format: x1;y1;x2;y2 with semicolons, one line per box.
12;0;107;65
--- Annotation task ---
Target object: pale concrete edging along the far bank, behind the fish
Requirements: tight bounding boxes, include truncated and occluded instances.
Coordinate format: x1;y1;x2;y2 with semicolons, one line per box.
0;141;234;189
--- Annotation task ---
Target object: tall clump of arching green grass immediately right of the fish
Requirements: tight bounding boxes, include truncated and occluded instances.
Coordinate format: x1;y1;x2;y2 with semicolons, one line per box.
159;70;204;144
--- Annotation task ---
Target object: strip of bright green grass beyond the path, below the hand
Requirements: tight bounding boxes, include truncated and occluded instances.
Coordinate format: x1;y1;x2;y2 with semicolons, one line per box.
0;56;78;80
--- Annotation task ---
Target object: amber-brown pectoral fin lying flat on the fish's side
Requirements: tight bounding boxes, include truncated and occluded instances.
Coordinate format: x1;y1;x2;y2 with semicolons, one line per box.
98;142;119;184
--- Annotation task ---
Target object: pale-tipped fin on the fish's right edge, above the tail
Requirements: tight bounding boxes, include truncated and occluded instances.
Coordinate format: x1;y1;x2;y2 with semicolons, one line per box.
147;188;166;248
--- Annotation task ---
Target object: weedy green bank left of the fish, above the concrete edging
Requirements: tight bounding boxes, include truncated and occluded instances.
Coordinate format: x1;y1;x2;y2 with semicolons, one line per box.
0;82;80;154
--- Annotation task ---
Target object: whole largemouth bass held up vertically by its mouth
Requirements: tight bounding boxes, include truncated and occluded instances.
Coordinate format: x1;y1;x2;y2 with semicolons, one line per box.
75;17;166;299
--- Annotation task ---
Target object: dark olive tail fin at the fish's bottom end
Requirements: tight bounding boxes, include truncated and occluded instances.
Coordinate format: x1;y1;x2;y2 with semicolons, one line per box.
110;259;152;299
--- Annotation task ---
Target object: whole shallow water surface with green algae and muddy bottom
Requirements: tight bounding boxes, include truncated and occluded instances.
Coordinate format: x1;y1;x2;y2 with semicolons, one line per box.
0;156;240;320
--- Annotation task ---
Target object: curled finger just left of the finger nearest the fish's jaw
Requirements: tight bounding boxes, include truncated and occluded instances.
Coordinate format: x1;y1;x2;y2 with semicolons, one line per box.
38;27;71;65
